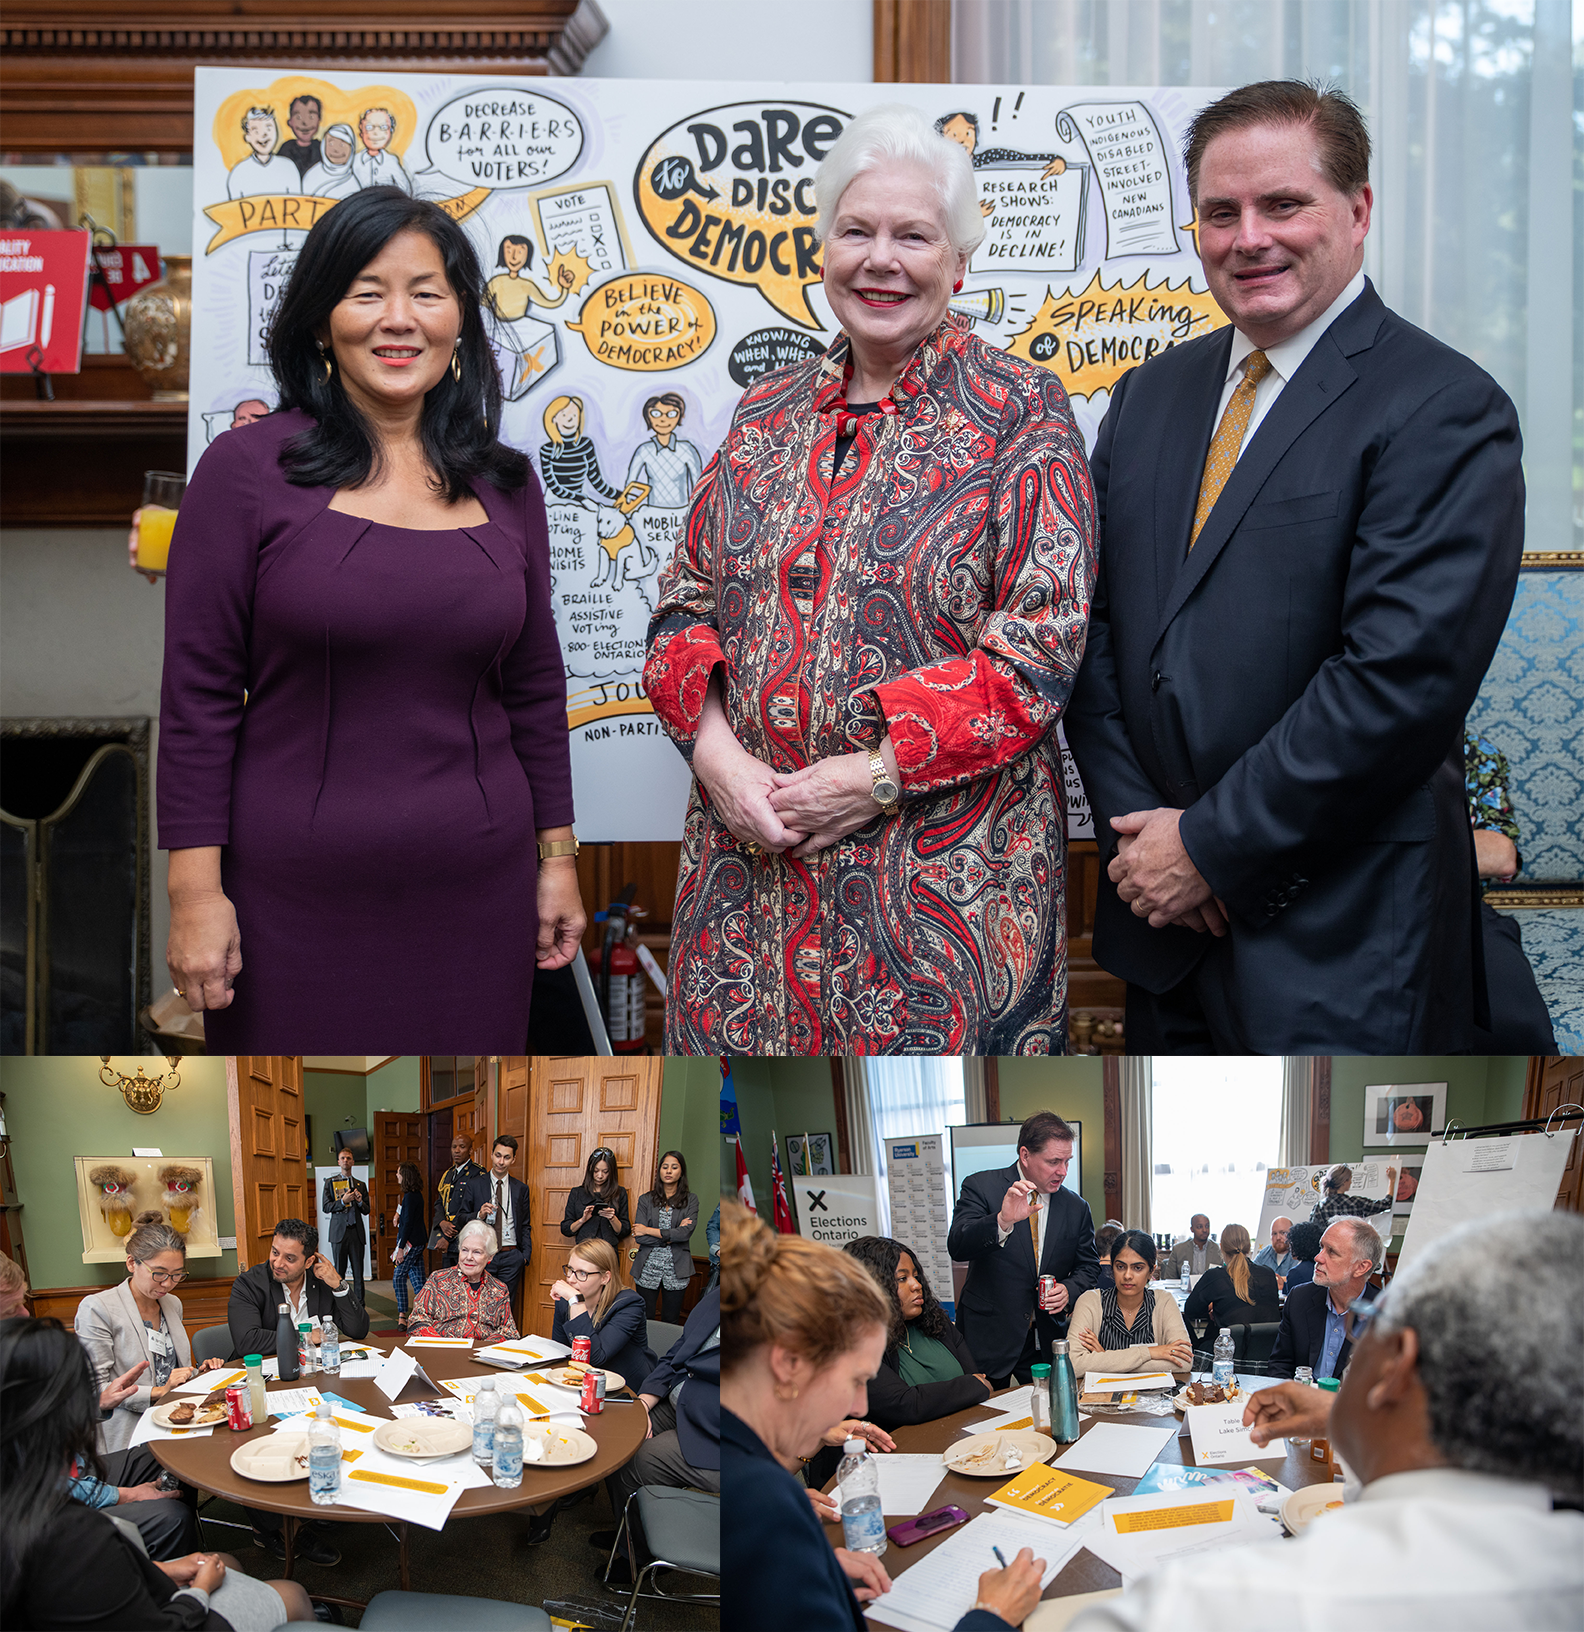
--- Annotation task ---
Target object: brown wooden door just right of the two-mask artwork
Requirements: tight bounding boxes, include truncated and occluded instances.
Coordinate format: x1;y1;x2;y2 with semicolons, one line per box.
225;1054;308;1270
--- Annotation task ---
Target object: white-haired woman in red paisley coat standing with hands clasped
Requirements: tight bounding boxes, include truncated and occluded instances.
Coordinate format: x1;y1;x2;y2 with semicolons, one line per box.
644;106;1095;1054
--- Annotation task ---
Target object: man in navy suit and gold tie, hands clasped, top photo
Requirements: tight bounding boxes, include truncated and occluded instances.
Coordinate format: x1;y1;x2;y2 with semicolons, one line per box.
1065;82;1524;1054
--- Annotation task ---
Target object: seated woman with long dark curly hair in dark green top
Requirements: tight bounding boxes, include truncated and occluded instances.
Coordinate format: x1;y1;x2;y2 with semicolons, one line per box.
843;1235;990;1428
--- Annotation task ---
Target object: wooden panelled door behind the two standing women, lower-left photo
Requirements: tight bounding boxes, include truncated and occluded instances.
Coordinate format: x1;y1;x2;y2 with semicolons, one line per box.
519;1054;666;1335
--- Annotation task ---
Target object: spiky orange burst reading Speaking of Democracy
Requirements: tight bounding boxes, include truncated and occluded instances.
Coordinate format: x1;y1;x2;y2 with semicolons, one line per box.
1007;273;1227;397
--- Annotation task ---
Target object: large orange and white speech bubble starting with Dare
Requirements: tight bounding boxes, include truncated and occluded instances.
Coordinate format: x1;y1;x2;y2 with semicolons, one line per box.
633;100;852;330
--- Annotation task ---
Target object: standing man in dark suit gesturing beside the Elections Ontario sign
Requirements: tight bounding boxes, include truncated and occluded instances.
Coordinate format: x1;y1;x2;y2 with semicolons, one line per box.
946;1111;1100;1389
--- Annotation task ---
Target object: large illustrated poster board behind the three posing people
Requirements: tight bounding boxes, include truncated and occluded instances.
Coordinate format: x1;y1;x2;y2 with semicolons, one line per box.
188;65;1225;840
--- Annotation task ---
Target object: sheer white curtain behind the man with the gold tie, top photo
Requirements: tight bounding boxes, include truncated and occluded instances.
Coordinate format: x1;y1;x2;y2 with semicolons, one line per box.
953;0;1584;550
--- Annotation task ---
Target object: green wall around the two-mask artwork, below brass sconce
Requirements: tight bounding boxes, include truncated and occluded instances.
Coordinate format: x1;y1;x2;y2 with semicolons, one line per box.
0;1054;237;1291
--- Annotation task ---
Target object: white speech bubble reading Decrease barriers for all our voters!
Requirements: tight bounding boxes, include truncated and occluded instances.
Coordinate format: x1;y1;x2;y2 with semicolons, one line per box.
413;85;584;189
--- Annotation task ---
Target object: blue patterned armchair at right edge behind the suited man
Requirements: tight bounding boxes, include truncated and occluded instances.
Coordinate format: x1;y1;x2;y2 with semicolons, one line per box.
1468;565;1584;1054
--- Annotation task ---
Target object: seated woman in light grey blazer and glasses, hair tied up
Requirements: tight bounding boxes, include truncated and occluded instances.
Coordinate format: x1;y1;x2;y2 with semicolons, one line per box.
75;1209;223;1455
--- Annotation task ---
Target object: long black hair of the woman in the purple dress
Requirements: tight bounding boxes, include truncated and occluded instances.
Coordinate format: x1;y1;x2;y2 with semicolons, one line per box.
269;188;529;503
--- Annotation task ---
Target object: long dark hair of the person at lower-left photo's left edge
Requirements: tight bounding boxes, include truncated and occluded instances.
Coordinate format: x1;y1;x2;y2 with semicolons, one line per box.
0;1317;104;1622
